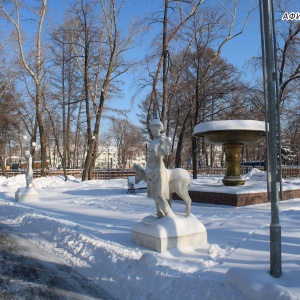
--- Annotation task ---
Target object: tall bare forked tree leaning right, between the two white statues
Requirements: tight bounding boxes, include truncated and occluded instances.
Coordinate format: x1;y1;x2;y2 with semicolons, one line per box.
61;0;132;180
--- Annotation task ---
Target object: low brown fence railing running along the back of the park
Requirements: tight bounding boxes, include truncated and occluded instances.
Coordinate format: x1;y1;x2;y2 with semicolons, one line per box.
0;166;300;180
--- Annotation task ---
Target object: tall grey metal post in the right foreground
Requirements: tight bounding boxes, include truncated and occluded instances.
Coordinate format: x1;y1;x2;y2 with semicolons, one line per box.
260;0;282;278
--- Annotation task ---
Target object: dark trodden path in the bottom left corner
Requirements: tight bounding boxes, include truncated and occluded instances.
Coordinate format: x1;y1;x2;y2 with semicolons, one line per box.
0;227;113;300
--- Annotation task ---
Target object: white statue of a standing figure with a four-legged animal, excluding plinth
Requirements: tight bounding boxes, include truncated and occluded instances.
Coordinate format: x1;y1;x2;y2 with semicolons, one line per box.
134;119;191;218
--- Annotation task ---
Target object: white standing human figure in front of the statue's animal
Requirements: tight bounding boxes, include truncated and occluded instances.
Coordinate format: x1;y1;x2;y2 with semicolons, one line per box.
145;119;171;218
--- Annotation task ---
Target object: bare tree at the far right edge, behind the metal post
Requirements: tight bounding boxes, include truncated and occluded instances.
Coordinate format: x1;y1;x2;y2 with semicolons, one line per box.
252;0;300;156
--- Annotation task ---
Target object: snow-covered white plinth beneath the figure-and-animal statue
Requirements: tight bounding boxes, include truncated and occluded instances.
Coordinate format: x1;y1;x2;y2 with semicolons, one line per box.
131;211;207;253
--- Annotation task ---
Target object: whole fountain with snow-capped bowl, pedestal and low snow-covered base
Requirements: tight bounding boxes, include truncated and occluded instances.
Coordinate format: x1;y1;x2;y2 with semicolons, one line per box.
173;120;300;206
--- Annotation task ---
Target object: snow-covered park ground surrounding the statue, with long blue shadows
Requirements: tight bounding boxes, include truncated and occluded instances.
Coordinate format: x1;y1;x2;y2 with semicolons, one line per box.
0;175;300;300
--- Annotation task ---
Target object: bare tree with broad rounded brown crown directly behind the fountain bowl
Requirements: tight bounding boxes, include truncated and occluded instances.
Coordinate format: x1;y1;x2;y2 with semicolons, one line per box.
169;47;245;167
